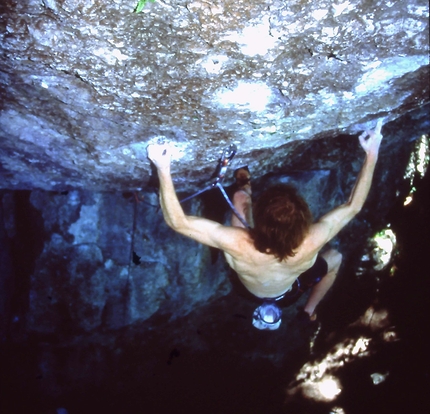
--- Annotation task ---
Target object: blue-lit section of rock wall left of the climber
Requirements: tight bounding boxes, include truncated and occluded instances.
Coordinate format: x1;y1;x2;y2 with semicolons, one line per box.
22;191;232;333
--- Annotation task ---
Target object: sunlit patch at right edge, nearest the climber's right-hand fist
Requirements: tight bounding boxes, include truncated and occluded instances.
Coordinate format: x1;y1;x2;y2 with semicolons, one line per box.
403;134;430;206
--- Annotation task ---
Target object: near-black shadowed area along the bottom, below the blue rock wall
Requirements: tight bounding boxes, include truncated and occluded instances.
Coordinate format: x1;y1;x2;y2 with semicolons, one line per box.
2;168;430;414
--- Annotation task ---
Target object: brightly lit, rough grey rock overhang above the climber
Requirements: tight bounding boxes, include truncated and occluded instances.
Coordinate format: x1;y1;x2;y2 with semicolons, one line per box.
0;0;428;191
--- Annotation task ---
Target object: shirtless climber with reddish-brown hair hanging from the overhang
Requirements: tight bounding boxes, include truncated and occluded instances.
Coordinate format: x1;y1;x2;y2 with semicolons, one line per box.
148;120;382;329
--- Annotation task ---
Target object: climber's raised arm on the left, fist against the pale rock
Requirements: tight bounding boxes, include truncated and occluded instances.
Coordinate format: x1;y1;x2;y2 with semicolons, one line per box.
148;144;245;254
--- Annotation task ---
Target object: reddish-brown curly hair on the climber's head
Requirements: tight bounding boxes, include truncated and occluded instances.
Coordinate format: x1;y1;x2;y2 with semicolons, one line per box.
250;184;312;260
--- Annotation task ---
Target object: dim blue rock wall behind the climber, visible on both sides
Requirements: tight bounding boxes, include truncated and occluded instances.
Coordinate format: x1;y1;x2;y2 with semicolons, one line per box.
0;108;430;334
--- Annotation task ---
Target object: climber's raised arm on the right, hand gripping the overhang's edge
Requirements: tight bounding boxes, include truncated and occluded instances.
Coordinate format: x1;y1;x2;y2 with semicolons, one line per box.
312;120;382;246
